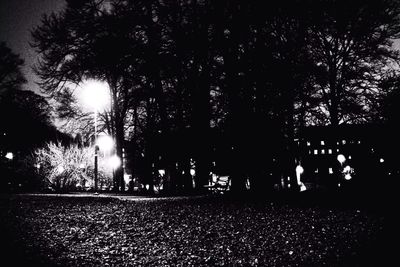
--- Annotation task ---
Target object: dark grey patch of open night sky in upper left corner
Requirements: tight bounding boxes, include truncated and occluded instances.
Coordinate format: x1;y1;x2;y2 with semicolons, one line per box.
0;0;65;94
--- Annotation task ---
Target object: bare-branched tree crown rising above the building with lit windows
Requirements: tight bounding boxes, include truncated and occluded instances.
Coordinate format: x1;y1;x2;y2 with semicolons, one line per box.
308;0;400;126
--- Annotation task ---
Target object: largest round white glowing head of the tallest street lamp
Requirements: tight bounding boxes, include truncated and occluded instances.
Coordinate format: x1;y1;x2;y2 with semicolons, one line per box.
81;80;110;111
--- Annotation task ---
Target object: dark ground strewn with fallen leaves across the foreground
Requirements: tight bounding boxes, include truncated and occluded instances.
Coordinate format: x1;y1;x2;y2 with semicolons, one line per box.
0;195;388;266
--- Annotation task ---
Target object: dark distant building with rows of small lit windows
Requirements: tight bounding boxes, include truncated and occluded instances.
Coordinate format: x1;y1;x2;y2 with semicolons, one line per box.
295;125;399;190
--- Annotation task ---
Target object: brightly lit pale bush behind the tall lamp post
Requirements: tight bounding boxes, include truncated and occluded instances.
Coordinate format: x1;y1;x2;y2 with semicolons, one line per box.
35;143;111;191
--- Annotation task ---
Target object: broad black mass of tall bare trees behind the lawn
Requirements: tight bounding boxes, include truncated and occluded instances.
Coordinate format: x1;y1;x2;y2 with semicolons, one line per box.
32;0;400;197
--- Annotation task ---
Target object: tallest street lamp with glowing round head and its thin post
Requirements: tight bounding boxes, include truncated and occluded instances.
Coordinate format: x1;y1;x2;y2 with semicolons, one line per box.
80;80;110;193
